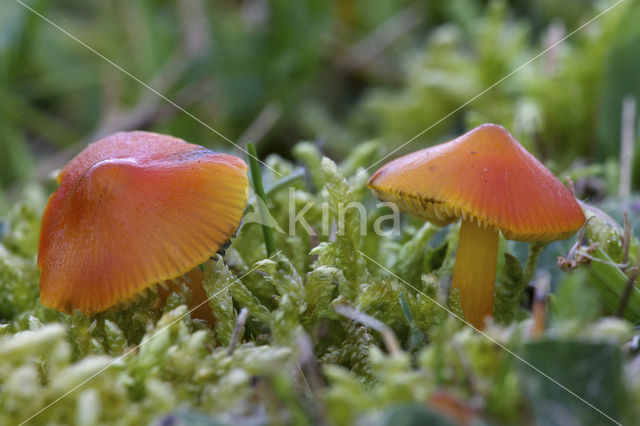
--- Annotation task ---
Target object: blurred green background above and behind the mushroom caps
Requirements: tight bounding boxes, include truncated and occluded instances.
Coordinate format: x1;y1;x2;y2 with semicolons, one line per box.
0;0;640;213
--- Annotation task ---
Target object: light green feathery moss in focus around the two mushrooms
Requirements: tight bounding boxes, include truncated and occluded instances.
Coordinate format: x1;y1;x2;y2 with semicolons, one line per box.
0;141;640;425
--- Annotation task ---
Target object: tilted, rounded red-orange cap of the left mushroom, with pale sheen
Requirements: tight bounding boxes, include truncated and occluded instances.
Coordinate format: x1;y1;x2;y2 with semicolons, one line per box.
38;132;249;314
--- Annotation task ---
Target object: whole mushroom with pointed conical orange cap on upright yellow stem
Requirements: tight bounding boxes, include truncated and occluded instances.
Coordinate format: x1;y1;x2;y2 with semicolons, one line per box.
368;124;585;329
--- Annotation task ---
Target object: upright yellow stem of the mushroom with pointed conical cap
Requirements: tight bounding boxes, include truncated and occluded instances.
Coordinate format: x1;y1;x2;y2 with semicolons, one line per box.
453;219;499;330
